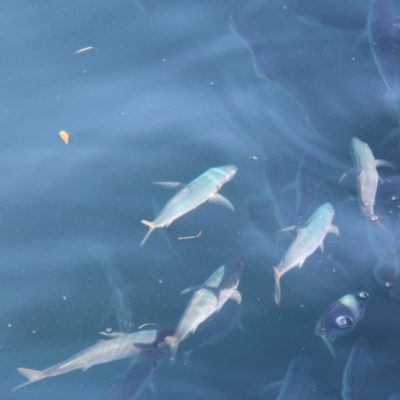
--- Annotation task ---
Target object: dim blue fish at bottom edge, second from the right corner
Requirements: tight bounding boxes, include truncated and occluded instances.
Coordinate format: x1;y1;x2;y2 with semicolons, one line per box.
276;354;315;400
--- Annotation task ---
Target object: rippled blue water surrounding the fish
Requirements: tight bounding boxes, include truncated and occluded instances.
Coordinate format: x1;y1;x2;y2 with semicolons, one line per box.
0;0;400;400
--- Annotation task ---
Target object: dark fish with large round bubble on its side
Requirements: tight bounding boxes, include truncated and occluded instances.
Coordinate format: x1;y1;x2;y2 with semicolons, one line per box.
315;292;369;358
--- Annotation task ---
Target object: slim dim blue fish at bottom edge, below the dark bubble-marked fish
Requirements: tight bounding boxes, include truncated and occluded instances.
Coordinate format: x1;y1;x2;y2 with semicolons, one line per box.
342;336;368;400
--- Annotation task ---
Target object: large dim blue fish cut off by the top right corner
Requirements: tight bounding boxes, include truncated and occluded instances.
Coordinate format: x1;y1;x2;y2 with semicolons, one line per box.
367;0;400;124
